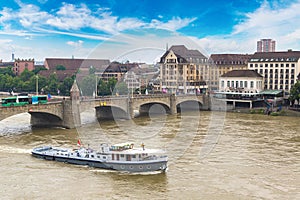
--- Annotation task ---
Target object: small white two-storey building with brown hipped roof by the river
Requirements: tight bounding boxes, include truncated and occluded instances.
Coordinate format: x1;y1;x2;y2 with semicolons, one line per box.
219;70;263;95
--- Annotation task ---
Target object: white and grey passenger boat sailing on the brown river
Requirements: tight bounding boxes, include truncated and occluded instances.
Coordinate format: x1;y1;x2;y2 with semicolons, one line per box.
31;143;168;172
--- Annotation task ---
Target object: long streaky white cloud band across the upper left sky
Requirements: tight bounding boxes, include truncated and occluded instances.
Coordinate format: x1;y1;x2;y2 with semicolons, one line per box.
0;1;196;35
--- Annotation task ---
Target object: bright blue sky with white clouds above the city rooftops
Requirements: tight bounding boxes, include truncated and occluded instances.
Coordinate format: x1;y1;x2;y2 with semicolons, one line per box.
0;0;300;63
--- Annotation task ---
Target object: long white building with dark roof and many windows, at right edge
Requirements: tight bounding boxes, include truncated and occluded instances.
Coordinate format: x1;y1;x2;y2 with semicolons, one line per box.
248;50;300;92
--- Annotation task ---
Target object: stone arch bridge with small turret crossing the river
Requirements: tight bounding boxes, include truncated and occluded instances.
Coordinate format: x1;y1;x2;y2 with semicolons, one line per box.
0;94;210;128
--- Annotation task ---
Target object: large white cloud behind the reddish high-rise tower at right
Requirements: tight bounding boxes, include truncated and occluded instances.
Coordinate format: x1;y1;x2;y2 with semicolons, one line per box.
196;0;300;53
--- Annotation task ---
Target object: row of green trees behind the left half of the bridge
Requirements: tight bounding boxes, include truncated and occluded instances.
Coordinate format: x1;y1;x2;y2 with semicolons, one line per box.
0;68;116;96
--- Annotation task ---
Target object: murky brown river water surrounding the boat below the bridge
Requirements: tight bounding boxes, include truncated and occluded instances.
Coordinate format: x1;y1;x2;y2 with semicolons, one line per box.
0;111;300;200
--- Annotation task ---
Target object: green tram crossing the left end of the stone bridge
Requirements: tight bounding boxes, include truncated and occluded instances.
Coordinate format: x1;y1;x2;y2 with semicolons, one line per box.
1;94;48;107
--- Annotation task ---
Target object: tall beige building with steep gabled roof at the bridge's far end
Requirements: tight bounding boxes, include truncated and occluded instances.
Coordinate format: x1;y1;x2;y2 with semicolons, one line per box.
160;45;209;94
